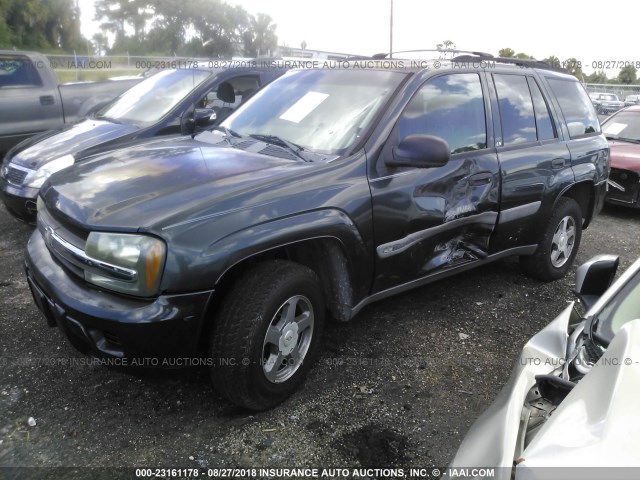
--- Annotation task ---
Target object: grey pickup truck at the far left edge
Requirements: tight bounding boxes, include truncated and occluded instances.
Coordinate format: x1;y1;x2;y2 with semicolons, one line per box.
0;50;143;158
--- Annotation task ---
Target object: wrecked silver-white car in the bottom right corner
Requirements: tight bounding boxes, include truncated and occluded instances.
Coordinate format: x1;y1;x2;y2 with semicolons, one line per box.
450;255;640;479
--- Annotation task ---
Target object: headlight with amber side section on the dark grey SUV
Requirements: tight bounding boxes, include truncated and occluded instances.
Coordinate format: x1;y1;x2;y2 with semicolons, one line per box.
84;232;167;297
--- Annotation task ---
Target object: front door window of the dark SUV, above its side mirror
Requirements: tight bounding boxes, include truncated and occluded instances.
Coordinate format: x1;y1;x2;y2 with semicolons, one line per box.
398;73;487;153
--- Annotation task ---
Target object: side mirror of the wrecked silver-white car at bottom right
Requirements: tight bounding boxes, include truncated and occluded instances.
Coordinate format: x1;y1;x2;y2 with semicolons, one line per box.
573;255;620;310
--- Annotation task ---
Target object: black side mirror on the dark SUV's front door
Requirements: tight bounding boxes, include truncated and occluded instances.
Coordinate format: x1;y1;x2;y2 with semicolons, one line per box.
385;134;451;168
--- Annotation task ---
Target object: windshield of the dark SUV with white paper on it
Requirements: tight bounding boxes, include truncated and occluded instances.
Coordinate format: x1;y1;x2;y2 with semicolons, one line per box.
222;69;406;155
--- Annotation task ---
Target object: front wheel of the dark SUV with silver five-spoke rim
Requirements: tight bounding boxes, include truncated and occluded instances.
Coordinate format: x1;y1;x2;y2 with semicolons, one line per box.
209;260;325;410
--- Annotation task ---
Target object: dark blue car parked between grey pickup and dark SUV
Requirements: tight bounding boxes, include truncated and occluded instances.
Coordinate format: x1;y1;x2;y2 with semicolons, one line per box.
0;62;285;222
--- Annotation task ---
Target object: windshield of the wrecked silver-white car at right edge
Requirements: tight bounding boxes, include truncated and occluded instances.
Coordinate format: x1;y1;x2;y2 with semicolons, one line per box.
593;273;640;345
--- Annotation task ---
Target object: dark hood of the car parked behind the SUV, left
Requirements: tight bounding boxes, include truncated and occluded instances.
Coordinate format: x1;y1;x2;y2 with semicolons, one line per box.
11;119;139;170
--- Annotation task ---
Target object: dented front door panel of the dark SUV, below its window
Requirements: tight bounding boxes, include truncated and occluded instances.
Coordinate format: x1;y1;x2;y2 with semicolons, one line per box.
371;150;500;292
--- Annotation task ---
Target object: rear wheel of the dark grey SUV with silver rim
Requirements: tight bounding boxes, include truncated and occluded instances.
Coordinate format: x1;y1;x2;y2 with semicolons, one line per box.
520;197;582;282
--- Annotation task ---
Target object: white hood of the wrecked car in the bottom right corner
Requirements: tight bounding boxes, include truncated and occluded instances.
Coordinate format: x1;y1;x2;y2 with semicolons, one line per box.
516;319;640;470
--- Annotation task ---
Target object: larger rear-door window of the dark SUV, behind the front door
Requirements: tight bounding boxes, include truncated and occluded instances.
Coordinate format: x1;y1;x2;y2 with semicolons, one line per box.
493;75;538;146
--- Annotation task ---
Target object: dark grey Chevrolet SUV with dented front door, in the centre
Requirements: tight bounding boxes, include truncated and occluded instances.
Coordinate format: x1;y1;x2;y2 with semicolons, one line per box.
26;56;609;409
